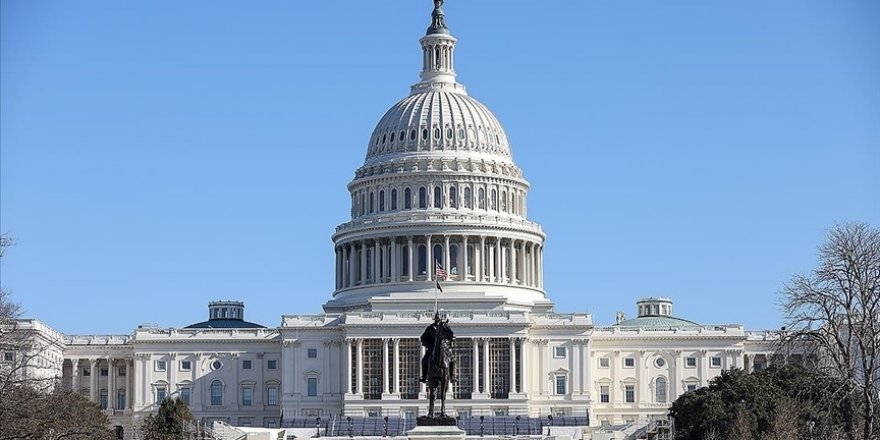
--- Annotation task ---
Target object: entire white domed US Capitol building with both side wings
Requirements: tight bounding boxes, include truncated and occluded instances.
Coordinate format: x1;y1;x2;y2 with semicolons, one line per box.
4;2;773;432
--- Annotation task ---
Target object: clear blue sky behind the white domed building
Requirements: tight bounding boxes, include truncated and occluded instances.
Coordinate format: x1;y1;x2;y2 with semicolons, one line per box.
0;0;880;333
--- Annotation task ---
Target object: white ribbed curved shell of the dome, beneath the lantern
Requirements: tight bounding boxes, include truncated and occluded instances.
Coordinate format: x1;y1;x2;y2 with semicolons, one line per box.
365;90;513;164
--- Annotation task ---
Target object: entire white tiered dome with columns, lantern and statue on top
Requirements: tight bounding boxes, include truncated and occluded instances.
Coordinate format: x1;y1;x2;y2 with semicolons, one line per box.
324;0;552;312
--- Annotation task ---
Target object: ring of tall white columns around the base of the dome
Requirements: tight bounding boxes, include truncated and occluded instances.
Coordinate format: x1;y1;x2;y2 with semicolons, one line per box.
336;234;544;291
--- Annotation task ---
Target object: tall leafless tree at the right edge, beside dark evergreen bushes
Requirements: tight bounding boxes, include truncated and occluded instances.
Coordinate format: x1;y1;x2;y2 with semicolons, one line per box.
781;223;880;440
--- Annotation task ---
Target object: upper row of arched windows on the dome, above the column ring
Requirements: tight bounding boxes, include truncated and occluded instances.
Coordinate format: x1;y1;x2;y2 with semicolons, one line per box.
351;185;525;217
